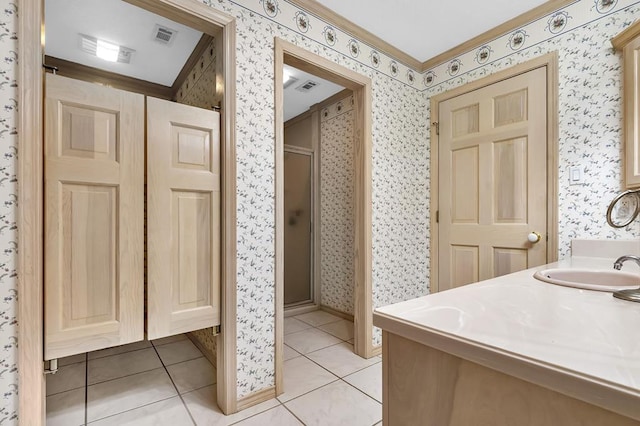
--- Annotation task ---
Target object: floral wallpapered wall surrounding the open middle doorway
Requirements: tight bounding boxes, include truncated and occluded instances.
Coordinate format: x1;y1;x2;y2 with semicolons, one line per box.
200;0;429;397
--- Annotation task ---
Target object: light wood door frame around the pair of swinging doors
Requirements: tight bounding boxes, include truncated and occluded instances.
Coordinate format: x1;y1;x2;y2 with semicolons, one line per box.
17;0;238;425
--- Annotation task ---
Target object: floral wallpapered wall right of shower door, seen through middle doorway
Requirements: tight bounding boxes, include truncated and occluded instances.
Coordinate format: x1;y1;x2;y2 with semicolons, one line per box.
320;96;355;315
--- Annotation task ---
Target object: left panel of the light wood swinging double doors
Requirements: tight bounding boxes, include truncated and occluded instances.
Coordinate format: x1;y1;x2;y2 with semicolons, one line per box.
44;74;144;359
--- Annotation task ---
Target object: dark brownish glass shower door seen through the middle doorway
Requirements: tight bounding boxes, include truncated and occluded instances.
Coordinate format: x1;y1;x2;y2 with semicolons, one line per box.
284;148;313;307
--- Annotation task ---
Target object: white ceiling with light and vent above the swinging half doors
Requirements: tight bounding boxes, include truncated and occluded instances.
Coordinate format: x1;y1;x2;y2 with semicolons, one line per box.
45;0;202;87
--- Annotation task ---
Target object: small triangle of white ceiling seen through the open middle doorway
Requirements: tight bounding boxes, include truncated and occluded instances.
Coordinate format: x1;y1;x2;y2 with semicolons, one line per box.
284;65;344;122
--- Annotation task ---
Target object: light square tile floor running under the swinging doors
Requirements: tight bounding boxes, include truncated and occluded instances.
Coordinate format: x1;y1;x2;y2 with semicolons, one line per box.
47;311;382;426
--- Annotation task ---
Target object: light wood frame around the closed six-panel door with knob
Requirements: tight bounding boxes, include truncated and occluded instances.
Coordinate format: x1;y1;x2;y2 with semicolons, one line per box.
429;51;558;293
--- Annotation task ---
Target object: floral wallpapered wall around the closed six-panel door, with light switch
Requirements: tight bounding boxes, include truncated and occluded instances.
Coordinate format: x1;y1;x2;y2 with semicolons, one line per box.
424;0;640;258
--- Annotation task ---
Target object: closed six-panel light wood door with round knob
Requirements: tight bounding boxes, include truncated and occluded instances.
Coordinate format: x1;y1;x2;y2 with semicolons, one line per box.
438;68;547;290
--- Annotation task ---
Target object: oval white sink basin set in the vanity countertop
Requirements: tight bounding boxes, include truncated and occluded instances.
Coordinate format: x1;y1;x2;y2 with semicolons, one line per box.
533;268;640;291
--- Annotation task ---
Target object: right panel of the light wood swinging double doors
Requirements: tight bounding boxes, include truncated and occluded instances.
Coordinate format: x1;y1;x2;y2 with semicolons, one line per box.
147;97;220;339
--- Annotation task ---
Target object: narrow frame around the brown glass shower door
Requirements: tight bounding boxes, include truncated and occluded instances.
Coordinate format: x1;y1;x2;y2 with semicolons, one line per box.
283;144;320;311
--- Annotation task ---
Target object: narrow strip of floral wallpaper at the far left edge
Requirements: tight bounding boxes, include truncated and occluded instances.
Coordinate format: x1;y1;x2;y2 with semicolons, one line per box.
0;1;18;425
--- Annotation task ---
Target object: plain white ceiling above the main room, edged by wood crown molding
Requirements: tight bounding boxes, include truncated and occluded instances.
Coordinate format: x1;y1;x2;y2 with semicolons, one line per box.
317;0;547;62
